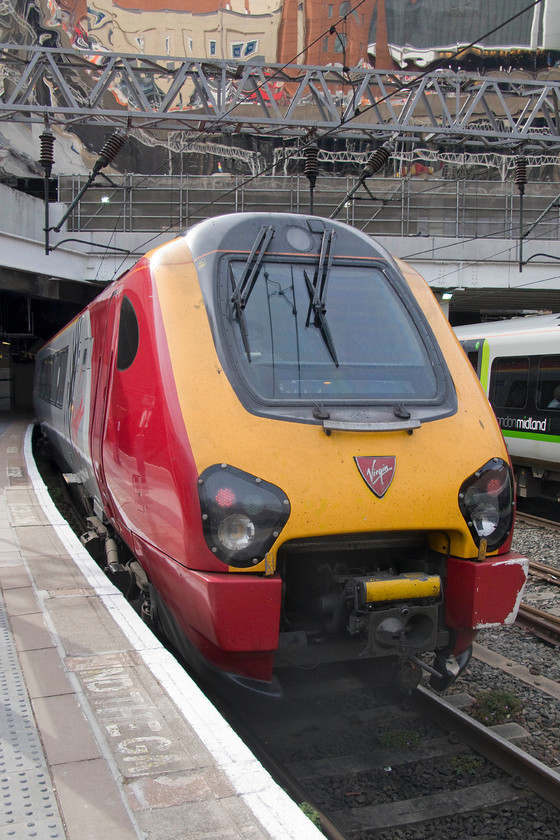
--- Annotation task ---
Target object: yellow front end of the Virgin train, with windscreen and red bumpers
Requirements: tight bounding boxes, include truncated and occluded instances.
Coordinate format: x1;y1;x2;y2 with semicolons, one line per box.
147;215;527;688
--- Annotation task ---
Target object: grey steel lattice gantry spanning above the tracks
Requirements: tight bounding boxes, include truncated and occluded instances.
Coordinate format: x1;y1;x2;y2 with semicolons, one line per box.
0;44;560;152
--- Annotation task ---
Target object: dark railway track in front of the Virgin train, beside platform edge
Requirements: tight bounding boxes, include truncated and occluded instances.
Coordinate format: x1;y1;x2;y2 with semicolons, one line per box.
218;669;560;840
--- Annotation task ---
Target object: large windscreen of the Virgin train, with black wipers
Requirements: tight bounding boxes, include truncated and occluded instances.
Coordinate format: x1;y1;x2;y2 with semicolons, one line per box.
227;260;437;402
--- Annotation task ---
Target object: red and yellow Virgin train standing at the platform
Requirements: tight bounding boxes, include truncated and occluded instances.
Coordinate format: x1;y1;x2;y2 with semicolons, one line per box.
35;213;527;688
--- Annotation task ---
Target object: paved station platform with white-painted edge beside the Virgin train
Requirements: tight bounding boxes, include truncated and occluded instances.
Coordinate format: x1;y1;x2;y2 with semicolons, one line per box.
0;413;324;840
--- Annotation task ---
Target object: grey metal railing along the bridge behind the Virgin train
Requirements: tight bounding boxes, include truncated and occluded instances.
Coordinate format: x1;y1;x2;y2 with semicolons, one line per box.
55;175;560;240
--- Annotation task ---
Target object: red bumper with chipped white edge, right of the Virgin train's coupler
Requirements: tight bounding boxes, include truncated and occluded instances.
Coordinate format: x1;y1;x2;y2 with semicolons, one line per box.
445;551;529;630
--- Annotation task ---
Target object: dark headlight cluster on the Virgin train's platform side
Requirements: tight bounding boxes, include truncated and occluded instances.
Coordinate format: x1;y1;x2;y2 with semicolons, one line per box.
198;464;290;568
